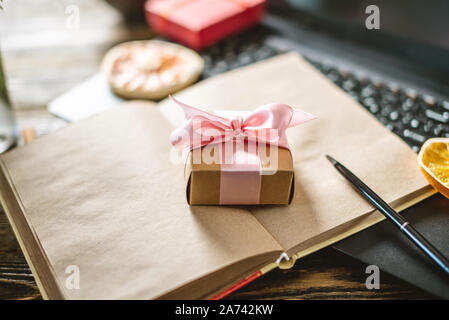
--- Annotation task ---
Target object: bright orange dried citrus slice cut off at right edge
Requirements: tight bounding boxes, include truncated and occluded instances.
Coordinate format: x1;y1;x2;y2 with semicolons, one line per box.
418;138;449;198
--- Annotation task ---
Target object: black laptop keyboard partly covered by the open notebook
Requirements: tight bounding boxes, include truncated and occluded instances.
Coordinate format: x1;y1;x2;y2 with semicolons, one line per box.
200;28;449;152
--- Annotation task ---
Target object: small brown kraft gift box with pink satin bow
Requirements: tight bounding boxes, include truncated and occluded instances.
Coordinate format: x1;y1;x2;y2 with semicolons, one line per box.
170;98;315;205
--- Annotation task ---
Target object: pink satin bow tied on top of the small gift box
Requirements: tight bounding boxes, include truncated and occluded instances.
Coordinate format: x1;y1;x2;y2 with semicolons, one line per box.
170;97;316;150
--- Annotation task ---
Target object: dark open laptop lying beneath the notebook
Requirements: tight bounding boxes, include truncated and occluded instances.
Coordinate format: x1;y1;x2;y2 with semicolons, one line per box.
194;0;449;299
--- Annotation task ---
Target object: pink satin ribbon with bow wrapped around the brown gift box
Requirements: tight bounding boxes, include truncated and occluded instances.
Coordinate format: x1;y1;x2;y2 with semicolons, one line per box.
170;97;316;204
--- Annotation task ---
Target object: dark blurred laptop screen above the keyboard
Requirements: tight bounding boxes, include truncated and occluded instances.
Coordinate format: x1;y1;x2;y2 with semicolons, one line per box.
269;0;449;73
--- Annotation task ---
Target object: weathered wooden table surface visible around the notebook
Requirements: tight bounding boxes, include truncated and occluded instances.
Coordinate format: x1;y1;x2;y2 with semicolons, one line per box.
0;0;432;299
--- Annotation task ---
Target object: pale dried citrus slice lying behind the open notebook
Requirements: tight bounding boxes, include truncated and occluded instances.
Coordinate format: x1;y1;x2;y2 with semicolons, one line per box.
102;40;204;99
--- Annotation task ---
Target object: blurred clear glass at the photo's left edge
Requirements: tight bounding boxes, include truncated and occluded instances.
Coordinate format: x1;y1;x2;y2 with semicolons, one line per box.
0;46;17;153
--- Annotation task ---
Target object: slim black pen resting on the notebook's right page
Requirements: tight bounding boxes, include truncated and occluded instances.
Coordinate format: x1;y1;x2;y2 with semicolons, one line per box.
326;155;449;274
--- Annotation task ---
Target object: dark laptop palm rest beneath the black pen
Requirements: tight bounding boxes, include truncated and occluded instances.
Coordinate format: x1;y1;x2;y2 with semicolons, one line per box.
334;194;449;299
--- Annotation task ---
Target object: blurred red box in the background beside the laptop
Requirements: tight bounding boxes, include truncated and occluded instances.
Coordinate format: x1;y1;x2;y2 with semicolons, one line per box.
145;0;266;50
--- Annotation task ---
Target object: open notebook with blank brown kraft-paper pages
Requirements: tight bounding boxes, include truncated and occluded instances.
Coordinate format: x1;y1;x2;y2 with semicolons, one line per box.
0;53;433;299
